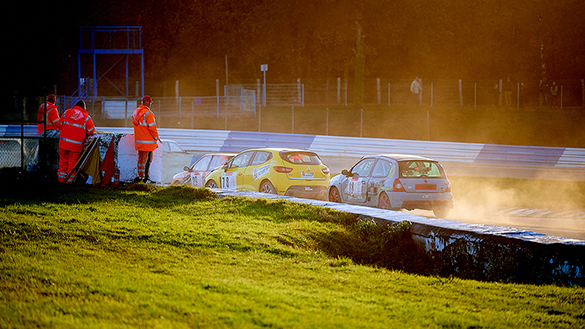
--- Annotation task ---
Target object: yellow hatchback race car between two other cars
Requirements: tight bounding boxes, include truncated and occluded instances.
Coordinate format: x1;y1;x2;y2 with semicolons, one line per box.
205;148;331;200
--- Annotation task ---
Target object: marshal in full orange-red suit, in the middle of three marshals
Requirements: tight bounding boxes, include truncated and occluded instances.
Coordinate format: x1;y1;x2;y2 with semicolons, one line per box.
57;99;95;184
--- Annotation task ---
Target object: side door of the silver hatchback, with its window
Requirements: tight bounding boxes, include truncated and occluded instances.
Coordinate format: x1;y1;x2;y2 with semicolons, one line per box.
340;158;376;204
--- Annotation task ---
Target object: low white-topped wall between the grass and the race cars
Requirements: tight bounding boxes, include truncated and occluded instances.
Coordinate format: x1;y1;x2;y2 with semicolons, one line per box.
214;189;585;286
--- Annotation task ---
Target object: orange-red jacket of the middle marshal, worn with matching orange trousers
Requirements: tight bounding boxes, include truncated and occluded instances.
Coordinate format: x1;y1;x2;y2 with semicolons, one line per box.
59;106;95;152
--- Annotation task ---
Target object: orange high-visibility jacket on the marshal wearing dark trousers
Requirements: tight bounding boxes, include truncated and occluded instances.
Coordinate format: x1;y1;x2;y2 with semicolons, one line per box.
132;105;159;151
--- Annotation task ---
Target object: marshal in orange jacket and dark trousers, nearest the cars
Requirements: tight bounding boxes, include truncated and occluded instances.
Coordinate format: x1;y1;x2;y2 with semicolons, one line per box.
132;95;160;182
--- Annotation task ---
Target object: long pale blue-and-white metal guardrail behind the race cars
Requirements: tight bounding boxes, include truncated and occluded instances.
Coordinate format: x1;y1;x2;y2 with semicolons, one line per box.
0;125;585;169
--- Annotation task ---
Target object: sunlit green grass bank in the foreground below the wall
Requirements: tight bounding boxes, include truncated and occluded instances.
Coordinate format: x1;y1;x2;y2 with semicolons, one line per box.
0;184;585;328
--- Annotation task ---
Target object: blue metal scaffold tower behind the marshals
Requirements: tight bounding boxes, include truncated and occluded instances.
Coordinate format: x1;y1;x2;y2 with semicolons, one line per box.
77;26;144;100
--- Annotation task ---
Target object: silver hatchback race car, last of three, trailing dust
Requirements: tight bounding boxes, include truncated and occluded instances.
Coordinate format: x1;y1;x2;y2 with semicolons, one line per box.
329;154;453;218
